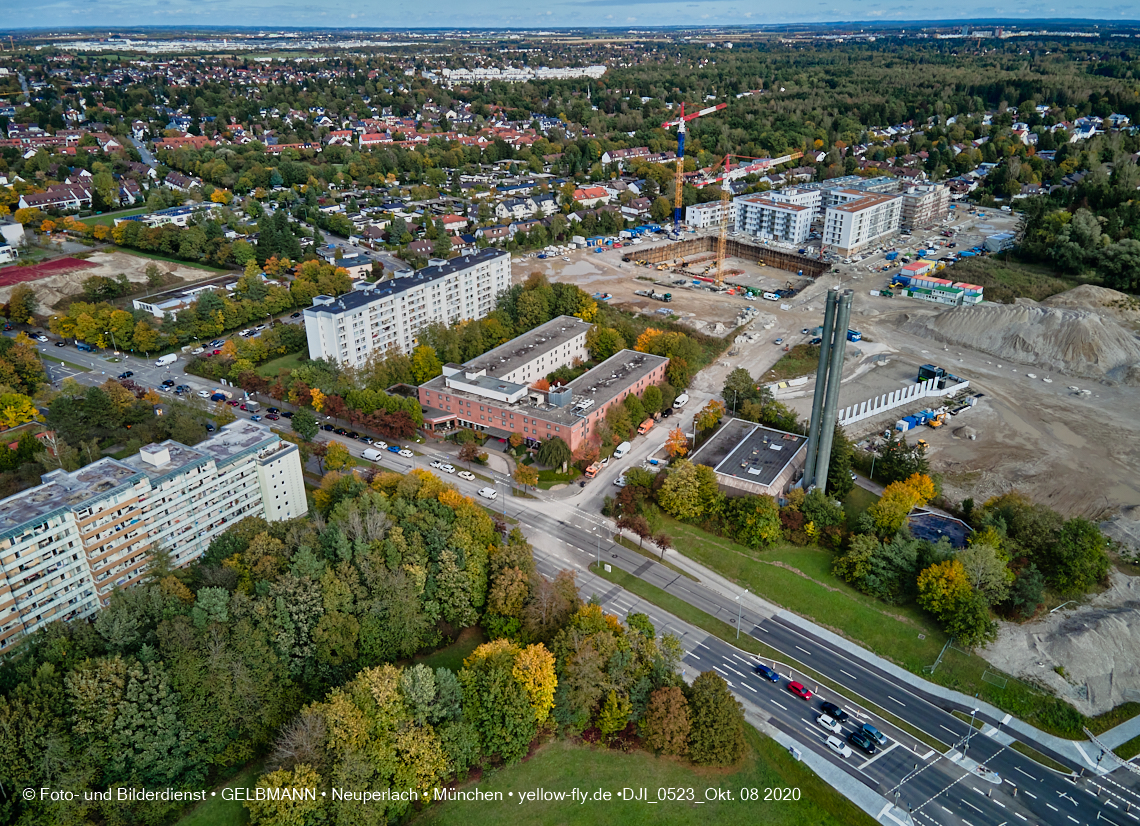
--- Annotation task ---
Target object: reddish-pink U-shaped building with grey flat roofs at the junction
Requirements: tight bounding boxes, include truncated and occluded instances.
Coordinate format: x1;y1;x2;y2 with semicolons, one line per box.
420;316;669;450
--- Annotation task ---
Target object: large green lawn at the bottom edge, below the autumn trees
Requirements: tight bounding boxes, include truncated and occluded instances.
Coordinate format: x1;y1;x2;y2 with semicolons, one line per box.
414;726;872;826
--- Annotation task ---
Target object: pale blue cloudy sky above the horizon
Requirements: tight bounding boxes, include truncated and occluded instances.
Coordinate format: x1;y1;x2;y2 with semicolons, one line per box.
0;0;1140;28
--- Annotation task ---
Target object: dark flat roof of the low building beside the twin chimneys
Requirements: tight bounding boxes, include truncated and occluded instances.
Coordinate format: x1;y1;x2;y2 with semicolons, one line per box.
692;418;807;485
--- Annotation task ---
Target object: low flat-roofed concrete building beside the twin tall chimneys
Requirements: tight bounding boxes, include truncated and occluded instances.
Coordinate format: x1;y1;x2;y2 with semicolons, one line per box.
691;418;807;499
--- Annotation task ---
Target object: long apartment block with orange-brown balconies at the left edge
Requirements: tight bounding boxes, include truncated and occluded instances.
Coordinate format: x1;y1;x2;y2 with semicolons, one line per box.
0;420;308;651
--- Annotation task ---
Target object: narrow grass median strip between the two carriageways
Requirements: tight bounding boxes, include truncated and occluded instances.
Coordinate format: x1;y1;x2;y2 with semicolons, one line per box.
589;563;948;752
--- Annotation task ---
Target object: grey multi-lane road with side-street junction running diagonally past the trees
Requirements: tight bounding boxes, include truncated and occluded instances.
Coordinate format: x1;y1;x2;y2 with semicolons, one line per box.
13;325;1140;826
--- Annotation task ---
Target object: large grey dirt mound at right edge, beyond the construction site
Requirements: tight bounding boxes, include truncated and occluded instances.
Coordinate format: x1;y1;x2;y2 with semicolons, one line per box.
903;300;1140;383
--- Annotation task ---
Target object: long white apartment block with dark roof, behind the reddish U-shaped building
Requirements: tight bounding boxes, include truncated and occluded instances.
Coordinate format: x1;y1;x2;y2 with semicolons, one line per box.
304;250;511;365
